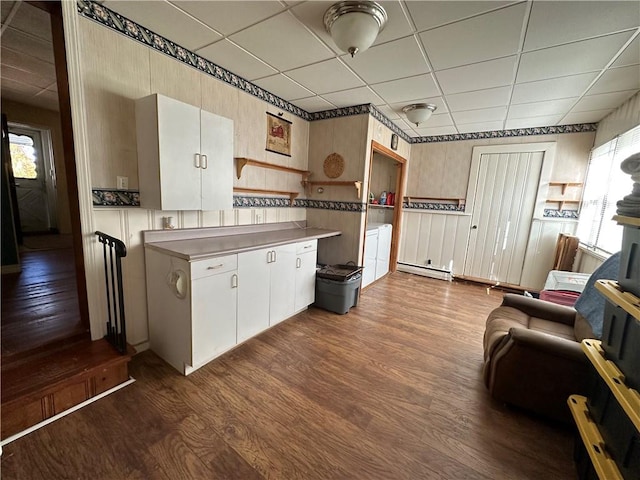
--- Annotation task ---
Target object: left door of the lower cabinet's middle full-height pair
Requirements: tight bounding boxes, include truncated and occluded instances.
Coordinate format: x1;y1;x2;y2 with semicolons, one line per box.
238;249;272;343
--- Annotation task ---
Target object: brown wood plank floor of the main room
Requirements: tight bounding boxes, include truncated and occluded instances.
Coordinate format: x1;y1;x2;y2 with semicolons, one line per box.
1;272;575;480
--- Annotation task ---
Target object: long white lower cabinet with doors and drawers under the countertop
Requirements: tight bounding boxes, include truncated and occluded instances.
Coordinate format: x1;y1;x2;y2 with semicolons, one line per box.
145;240;317;375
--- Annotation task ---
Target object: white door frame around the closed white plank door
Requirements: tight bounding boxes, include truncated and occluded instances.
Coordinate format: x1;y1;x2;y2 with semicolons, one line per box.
462;142;556;284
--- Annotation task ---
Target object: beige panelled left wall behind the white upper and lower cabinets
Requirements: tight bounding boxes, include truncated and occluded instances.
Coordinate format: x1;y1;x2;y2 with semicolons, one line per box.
79;18;309;345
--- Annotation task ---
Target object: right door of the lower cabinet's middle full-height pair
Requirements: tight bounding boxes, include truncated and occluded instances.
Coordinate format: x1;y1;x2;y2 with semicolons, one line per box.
269;243;296;325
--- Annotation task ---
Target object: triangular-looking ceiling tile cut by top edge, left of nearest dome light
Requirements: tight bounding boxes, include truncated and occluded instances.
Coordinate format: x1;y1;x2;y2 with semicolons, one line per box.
170;0;285;35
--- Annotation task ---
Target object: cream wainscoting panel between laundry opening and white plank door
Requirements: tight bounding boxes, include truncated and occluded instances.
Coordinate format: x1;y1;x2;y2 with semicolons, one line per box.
398;210;471;275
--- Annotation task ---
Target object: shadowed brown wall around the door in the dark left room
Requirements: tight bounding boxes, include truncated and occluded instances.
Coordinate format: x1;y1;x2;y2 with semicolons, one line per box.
2;98;71;234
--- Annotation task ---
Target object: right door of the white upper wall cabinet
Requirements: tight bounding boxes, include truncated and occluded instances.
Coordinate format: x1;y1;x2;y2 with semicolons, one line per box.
200;110;233;210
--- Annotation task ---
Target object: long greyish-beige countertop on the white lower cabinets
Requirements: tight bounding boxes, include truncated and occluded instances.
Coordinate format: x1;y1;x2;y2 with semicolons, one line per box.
145;228;342;261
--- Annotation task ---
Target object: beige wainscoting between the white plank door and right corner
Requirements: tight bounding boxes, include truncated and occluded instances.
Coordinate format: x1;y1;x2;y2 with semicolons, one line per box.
520;219;578;290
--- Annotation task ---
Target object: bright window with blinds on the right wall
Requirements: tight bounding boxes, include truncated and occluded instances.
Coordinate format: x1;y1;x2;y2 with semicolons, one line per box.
577;125;640;254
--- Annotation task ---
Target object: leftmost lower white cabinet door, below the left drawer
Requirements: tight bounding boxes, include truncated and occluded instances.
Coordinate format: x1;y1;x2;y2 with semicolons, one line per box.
191;270;238;368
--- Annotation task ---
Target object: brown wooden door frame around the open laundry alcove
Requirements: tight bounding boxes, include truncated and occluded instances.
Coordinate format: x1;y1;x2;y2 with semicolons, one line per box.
362;140;407;273
